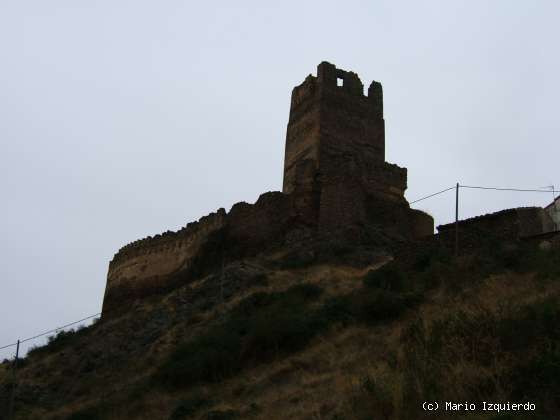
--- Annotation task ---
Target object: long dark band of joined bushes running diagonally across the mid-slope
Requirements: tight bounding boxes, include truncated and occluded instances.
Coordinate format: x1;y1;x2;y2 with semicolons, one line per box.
154;270;422;389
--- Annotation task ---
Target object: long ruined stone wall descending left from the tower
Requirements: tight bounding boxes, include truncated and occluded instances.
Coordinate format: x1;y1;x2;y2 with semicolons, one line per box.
103;192;316;316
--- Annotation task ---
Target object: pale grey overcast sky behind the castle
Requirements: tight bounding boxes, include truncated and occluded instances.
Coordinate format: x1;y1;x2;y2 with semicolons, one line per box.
0;0;560;358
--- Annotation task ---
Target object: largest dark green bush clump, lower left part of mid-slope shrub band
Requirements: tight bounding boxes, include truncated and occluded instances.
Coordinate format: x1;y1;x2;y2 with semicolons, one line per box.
155;285;326;388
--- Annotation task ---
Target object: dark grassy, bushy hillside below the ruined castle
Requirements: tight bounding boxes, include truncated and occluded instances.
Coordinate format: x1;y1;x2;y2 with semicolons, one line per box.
0;237;560;420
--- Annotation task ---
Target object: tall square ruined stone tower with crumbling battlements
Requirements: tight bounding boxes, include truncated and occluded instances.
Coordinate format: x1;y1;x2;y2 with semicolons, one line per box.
283;62;422;235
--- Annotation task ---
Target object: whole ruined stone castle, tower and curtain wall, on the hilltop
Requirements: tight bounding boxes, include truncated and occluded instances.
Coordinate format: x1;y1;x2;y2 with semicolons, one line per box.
103;62;434;316
